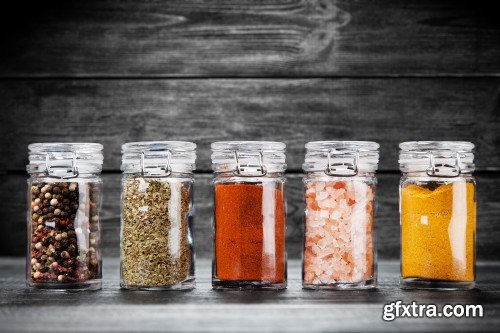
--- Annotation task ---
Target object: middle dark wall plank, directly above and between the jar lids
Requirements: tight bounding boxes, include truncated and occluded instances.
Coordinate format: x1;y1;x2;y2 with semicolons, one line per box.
0;78;500;171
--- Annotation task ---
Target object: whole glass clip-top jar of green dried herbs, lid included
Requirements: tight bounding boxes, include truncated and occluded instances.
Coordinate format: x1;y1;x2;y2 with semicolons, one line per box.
120;141;196;290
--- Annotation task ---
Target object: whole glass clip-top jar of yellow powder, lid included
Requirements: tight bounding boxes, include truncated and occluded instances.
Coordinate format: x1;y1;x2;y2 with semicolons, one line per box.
399;141;476;289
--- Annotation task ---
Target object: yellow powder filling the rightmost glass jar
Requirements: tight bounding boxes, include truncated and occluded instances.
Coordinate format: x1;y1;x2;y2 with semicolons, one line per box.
401;179;476;282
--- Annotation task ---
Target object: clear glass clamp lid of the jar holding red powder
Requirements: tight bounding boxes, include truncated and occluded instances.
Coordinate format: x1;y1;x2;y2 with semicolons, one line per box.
211;141;286;177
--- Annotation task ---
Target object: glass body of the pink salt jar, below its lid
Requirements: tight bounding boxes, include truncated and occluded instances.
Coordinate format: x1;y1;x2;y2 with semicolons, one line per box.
302;172;377;289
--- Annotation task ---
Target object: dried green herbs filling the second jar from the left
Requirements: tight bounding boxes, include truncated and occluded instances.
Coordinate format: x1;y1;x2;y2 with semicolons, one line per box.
121;176;192;287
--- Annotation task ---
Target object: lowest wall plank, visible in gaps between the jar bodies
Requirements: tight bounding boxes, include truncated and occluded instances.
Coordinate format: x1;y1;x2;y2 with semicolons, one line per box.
0;174;500;260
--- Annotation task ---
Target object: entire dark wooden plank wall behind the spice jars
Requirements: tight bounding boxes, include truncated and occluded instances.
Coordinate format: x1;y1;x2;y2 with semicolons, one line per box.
0;0;500;259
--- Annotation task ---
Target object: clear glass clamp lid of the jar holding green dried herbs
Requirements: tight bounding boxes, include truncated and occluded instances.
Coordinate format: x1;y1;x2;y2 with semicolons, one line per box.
121;141;196;177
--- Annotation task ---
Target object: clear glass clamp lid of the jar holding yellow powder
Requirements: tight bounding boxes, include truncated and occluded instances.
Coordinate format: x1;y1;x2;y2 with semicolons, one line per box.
399;141;475;177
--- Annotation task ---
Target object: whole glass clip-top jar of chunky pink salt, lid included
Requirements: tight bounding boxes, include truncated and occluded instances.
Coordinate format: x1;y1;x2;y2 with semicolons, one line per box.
302;141;379;289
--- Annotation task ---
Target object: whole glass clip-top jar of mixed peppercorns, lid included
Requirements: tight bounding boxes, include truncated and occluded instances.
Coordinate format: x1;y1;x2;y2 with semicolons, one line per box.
26;143;103;290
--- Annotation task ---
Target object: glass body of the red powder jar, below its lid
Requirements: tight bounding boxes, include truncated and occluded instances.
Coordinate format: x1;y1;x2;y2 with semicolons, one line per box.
212;172;287;289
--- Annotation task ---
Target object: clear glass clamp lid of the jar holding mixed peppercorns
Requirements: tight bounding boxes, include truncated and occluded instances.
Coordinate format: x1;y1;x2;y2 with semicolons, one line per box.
26;142;103;179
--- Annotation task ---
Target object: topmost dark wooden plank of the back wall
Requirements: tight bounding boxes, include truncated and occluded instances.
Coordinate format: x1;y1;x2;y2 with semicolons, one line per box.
0;0;500;77
